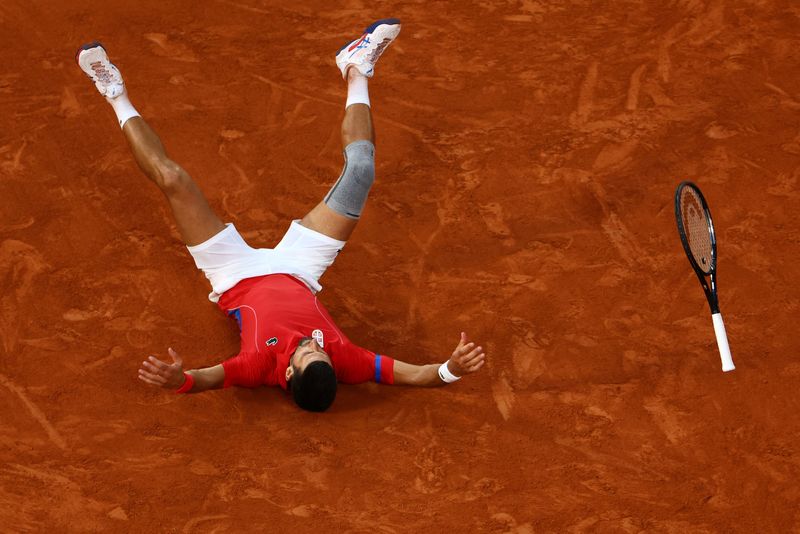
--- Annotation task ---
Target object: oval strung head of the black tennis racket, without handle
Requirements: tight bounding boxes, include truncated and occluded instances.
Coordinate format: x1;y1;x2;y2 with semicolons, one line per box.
675;181;717;277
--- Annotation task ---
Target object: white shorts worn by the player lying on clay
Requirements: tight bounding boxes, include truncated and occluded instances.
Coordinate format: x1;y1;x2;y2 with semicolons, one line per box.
191;220;345;302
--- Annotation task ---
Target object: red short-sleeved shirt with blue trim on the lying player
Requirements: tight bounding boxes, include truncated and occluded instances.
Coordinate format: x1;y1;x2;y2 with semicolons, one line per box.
218;274;394;389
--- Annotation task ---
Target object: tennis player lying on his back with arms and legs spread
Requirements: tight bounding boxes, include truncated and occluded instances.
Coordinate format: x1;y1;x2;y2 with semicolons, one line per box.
76;19;486;412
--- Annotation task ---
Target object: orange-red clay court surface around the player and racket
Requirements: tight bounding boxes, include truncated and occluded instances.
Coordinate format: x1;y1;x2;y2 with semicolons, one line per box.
0;0;800;534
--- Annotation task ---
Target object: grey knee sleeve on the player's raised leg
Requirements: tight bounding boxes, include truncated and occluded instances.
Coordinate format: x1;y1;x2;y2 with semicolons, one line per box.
325;141;375;219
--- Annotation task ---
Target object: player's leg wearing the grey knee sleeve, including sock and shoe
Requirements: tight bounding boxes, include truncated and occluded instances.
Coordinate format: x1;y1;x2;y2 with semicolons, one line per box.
300;19;400;241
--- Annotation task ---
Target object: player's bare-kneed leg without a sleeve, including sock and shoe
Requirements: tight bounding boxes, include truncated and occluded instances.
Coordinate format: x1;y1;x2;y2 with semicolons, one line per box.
75;42;225;246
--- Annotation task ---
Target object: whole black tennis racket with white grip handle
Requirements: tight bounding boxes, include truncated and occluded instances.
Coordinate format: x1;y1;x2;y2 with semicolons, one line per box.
675;182;735;372
